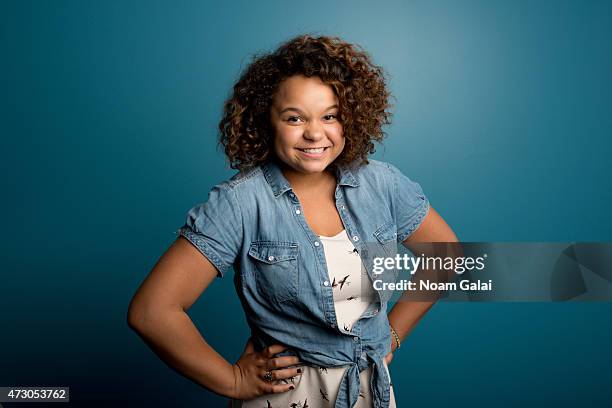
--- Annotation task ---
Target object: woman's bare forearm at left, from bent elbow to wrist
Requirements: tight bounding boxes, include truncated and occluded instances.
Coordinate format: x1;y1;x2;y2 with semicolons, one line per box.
132;308;234;396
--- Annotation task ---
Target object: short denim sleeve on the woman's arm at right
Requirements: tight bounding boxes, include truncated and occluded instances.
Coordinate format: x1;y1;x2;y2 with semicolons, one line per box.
387;163;429;242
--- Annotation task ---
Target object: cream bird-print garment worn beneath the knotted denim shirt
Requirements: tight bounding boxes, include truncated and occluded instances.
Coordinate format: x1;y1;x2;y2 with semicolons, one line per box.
230;230;396;408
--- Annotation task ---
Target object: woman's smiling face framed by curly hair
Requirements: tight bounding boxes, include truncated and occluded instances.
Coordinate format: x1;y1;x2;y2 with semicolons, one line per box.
270;75;344;174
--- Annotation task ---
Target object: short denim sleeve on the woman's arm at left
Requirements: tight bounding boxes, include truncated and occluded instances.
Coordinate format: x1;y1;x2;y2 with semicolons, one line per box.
176;184;243;278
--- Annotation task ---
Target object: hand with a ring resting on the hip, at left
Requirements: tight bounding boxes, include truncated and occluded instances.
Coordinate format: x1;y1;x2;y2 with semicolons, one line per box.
232;339;302;400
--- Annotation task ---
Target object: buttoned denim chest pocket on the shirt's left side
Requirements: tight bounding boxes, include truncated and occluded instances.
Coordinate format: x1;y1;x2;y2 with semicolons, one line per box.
249;241;299;303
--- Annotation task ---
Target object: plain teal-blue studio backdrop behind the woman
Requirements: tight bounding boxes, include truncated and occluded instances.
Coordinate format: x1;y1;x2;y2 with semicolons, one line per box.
0;0;612;407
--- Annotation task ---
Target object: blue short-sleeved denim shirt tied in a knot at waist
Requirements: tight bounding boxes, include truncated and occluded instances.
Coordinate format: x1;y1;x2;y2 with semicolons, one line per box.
177;159;429;408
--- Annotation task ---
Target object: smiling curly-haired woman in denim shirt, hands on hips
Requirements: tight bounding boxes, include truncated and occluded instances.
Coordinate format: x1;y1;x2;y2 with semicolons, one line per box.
128;35;456;408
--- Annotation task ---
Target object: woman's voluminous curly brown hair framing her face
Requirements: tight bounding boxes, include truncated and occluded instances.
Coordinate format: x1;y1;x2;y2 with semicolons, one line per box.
219;35;391;170
